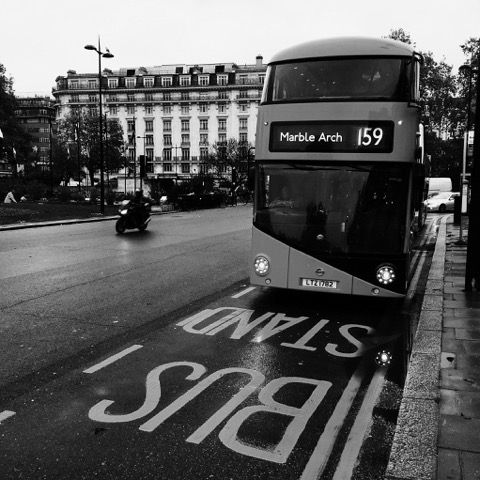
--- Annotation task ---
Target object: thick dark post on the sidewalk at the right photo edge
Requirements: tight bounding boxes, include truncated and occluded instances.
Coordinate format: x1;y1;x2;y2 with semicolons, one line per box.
463;61;480;292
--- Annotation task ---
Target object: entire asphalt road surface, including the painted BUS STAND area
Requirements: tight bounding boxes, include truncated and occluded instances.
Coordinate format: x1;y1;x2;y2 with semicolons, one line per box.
0;207;436;480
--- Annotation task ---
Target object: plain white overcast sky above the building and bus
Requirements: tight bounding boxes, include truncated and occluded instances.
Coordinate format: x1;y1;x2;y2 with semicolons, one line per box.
0;0;480;94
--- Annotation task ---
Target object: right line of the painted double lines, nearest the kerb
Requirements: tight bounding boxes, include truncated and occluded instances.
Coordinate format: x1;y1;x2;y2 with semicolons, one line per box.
332;368;387;480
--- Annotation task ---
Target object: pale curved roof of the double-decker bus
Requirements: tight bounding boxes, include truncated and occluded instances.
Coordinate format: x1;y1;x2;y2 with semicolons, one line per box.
270;37;415;63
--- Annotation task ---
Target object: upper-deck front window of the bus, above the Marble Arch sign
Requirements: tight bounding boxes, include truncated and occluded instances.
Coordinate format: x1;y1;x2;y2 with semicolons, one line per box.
266;57;411;102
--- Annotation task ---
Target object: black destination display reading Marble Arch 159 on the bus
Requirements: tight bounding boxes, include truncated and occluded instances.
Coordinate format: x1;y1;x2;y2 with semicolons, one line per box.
270;121;393;153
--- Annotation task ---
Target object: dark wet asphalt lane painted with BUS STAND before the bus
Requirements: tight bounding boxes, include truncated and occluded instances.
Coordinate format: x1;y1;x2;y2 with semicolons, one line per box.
0;288;399;480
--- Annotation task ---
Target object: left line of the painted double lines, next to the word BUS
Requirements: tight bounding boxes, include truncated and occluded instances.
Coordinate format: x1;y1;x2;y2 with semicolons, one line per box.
300;361;366;480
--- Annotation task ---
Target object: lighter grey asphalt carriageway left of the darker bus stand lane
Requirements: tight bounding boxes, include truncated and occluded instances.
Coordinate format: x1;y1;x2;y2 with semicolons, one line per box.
0;206;251;390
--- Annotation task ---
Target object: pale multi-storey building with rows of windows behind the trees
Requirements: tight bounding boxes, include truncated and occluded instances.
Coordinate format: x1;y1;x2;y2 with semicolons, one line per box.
53;56;266;188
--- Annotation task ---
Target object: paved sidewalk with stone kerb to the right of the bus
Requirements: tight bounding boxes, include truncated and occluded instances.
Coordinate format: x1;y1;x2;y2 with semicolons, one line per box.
385;215;480;480
